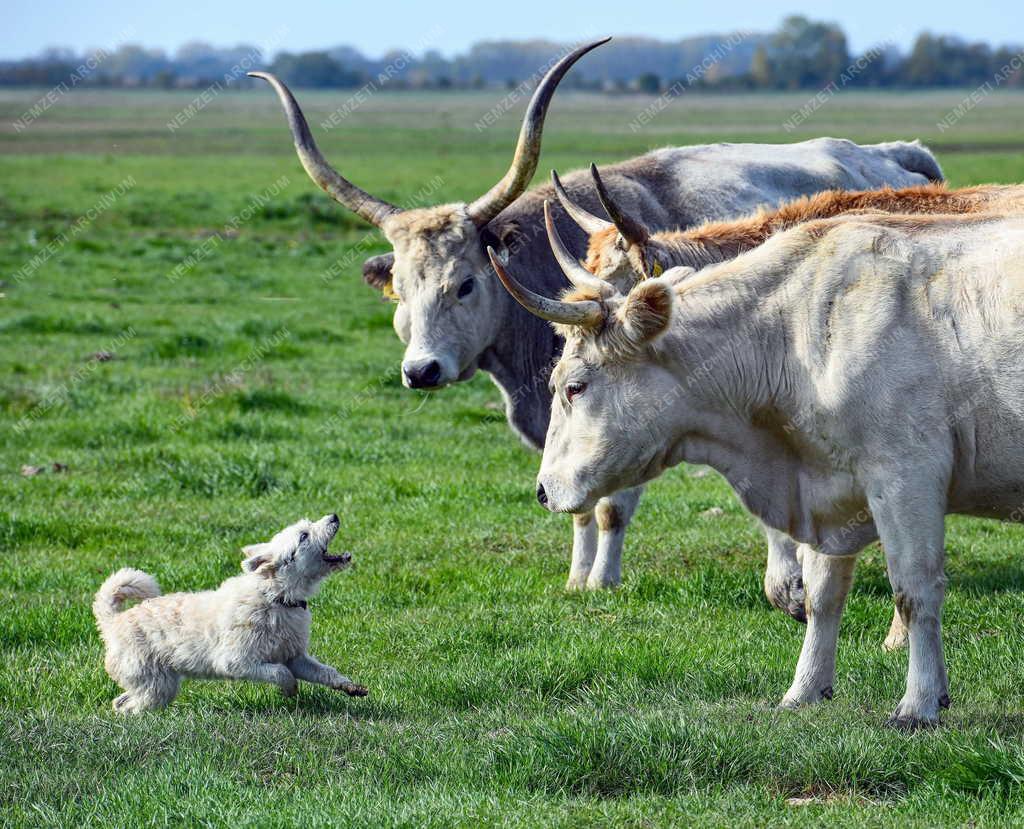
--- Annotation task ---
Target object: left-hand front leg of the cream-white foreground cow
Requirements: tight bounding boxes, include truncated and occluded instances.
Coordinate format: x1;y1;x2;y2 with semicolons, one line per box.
781;546;857;708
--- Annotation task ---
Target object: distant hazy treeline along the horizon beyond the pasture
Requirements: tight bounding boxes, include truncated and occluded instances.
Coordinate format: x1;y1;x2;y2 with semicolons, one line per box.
0;16;1024;93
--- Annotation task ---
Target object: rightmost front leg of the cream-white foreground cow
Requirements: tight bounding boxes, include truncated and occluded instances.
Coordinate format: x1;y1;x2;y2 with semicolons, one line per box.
867;478;949;729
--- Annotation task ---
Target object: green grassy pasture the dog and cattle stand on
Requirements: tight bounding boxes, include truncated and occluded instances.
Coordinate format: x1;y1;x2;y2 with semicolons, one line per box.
6;89;1024;826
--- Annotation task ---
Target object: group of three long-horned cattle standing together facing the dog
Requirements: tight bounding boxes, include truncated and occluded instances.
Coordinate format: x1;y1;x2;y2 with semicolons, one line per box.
253;41;1024;728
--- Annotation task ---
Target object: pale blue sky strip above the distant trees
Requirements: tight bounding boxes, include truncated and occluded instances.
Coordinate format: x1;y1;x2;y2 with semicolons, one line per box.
0;0;1024;59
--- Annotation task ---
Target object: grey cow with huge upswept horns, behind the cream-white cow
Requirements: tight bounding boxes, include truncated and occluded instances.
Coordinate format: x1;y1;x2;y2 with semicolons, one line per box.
252;41;942;587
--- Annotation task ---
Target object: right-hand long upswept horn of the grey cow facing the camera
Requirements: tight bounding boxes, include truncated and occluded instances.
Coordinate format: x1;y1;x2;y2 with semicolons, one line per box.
468;38;611;227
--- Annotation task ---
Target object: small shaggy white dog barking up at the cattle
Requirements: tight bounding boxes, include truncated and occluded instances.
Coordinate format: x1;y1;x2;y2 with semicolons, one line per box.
92;515;367;713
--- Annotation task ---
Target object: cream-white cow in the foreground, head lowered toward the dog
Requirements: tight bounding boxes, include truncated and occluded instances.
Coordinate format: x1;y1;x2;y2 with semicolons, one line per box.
495;214;1024;728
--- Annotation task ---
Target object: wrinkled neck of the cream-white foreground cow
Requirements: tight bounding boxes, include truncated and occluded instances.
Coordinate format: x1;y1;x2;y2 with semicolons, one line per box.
657;264;831;542
